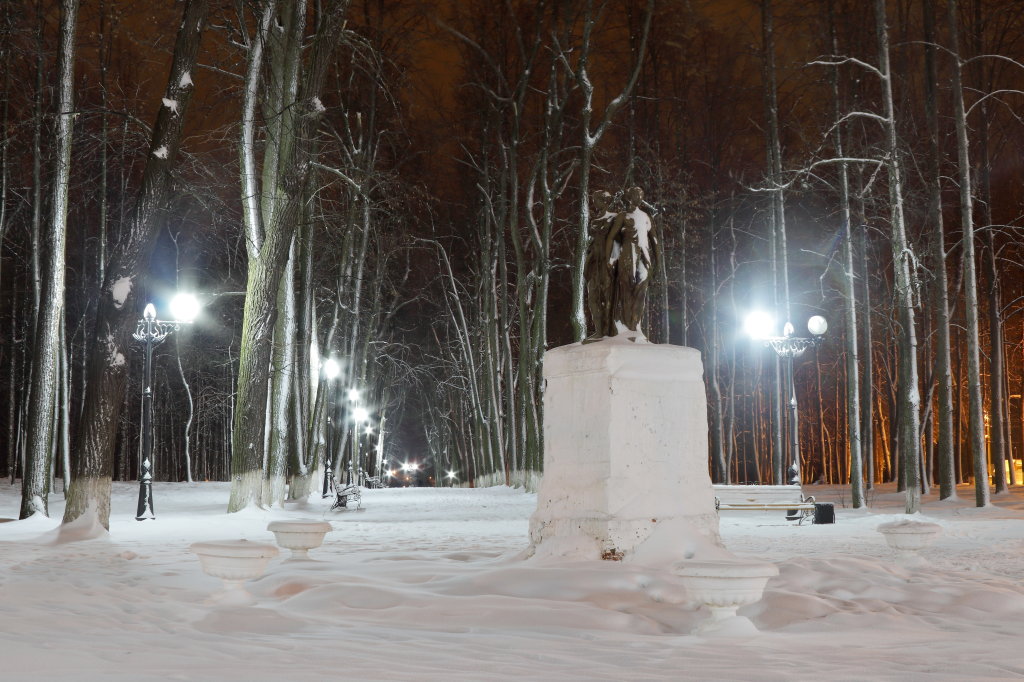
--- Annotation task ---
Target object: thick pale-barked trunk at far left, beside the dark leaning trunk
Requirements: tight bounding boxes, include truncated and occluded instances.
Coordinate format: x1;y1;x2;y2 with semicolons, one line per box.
20;0;78;518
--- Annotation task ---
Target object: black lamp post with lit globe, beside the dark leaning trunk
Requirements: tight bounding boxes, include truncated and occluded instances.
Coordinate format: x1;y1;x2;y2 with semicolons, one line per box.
132;294;199;521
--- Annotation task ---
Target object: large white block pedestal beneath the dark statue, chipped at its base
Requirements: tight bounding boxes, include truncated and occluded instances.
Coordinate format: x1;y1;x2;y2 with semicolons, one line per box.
529;337;721;562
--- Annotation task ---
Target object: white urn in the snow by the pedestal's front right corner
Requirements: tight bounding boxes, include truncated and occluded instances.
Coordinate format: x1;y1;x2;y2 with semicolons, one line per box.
673;560;778;633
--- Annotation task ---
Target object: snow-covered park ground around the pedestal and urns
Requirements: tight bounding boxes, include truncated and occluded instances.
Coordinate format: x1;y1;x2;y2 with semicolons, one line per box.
0;483;1024;682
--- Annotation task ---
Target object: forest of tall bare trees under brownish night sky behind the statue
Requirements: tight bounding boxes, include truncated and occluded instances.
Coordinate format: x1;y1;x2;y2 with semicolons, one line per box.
0;0;1024;524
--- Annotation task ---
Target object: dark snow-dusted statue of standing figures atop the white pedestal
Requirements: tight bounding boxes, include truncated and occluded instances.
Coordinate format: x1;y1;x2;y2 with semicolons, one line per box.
584;187;662;343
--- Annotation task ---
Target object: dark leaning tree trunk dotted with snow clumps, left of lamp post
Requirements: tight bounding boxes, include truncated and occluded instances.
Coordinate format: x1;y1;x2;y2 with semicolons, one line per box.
63;0;208;527
